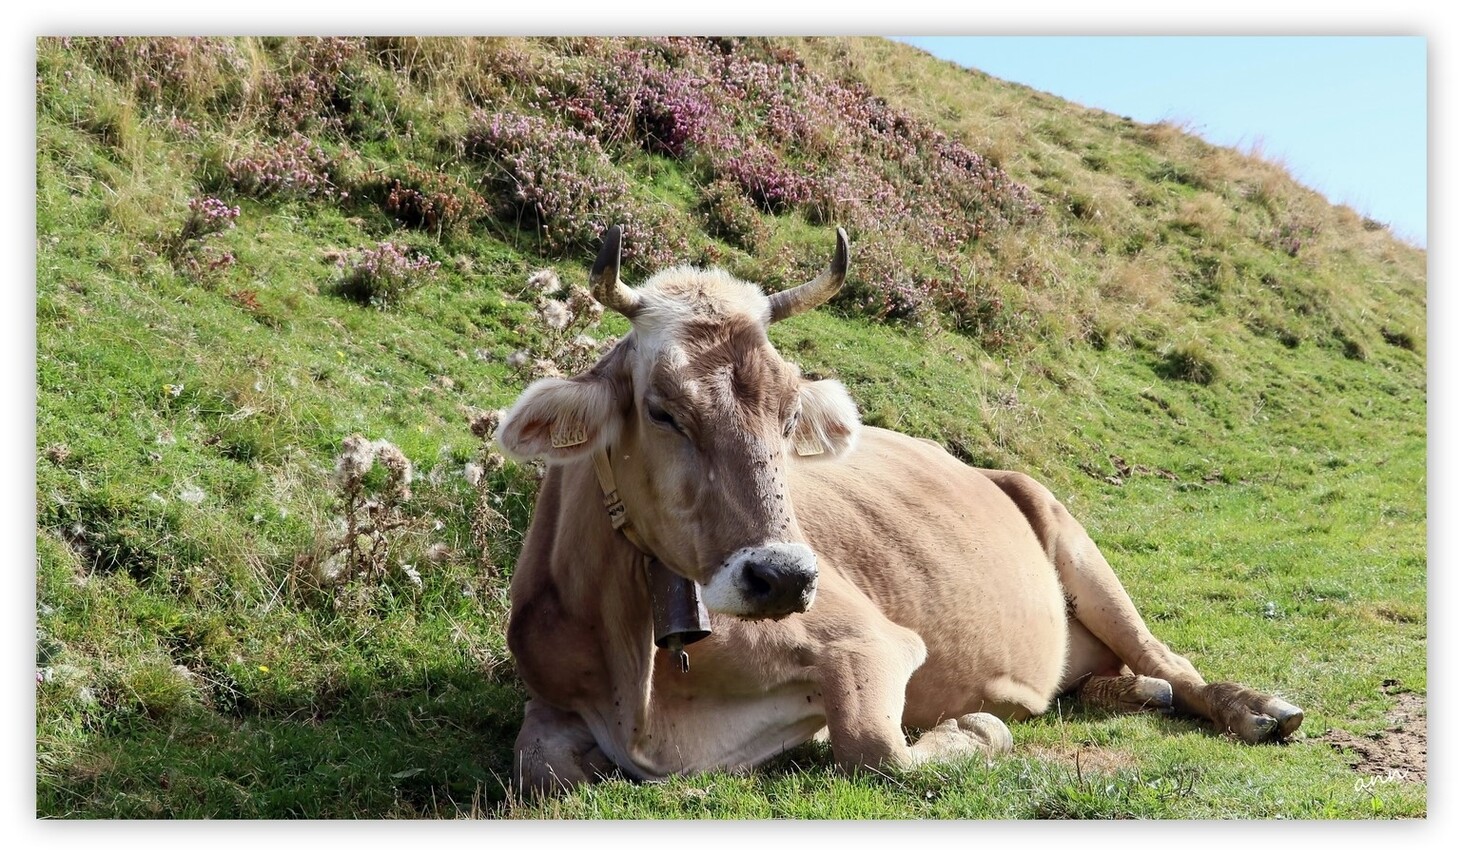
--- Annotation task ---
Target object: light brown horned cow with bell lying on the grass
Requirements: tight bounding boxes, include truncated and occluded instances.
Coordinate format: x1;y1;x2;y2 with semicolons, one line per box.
496;227;1304;795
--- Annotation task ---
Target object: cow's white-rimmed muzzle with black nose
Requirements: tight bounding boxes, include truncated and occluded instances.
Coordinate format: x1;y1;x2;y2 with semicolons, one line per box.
703;544;817;619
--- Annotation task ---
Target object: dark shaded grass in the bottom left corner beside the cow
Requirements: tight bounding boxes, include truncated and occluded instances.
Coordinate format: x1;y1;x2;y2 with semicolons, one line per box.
37;664;523;818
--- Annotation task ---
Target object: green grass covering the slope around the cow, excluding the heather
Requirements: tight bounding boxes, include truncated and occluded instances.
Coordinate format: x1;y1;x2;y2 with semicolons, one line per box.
35;40;1427;818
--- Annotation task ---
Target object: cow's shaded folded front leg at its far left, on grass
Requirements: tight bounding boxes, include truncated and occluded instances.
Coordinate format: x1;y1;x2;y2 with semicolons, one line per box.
513;699;616;797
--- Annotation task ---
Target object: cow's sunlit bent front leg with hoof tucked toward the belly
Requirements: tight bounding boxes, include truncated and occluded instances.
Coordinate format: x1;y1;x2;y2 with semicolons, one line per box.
820;614;1012;771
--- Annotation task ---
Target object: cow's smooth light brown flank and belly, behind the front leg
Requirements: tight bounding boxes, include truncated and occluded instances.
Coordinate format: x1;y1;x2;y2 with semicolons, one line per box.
791;427;1066;727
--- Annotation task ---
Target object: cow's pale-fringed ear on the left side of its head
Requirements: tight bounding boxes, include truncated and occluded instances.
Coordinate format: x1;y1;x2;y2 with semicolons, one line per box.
497;372;621;464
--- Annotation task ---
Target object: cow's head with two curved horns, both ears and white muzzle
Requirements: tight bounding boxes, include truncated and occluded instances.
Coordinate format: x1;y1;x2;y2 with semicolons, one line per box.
497;228;858;617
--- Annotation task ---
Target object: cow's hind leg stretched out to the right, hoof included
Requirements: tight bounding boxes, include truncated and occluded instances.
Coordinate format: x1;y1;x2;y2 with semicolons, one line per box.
987;471;1304;743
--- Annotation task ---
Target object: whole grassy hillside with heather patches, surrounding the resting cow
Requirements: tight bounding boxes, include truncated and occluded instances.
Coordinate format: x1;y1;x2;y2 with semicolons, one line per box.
35;38;1427;818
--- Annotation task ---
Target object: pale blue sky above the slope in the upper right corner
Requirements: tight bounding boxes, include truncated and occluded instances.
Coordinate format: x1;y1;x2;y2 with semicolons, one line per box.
899;35;1427;246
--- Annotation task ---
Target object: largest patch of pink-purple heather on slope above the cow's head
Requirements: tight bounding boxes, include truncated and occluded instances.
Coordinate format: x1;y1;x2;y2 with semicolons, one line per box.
497;38;1046;330
